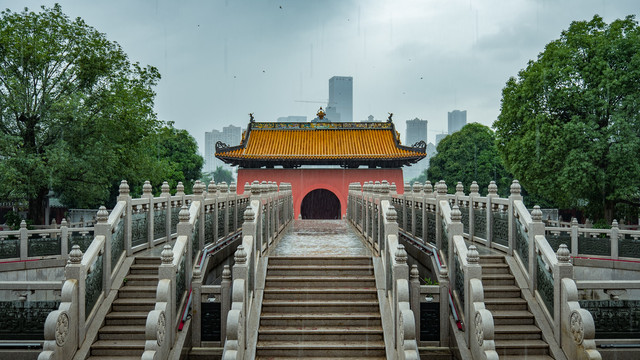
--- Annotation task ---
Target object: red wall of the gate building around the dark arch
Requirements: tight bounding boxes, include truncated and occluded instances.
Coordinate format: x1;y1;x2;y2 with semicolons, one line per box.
238;169;404;219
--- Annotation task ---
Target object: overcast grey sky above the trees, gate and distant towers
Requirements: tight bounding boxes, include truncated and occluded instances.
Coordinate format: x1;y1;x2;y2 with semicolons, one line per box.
5;0;640;152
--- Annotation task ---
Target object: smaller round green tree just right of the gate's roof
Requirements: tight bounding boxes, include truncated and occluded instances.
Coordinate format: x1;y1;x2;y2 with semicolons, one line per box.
427;123;513;195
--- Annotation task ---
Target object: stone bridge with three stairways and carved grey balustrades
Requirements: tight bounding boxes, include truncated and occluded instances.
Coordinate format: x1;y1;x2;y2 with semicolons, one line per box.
0;181;640;360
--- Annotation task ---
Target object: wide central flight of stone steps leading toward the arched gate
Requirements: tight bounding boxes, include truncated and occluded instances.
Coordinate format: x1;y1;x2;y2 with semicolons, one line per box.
256;256;386;359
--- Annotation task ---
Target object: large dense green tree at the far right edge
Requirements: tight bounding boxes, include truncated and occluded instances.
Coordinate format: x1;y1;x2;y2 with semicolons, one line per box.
494;15;640;223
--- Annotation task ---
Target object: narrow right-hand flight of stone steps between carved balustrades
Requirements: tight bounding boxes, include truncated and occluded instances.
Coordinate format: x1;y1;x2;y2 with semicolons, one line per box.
480;255;553;360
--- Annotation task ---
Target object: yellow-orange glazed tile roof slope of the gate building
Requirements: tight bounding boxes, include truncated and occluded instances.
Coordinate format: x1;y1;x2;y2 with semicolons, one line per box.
216;129;425;159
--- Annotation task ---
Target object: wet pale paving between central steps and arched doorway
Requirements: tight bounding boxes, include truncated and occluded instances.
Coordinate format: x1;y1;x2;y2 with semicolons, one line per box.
269;220;371;256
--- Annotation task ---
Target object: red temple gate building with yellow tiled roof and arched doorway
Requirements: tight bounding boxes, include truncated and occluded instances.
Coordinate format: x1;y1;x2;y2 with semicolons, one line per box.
216;109;426;219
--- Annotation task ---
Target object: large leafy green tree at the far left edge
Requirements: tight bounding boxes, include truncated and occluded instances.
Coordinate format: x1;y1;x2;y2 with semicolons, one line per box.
0;5;160;223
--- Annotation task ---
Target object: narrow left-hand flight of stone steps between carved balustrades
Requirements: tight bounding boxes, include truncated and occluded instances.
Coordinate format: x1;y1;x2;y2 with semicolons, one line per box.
88;257;160;360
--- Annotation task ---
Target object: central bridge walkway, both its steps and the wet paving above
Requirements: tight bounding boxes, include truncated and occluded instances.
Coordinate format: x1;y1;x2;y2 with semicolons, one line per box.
255;220;386;359
